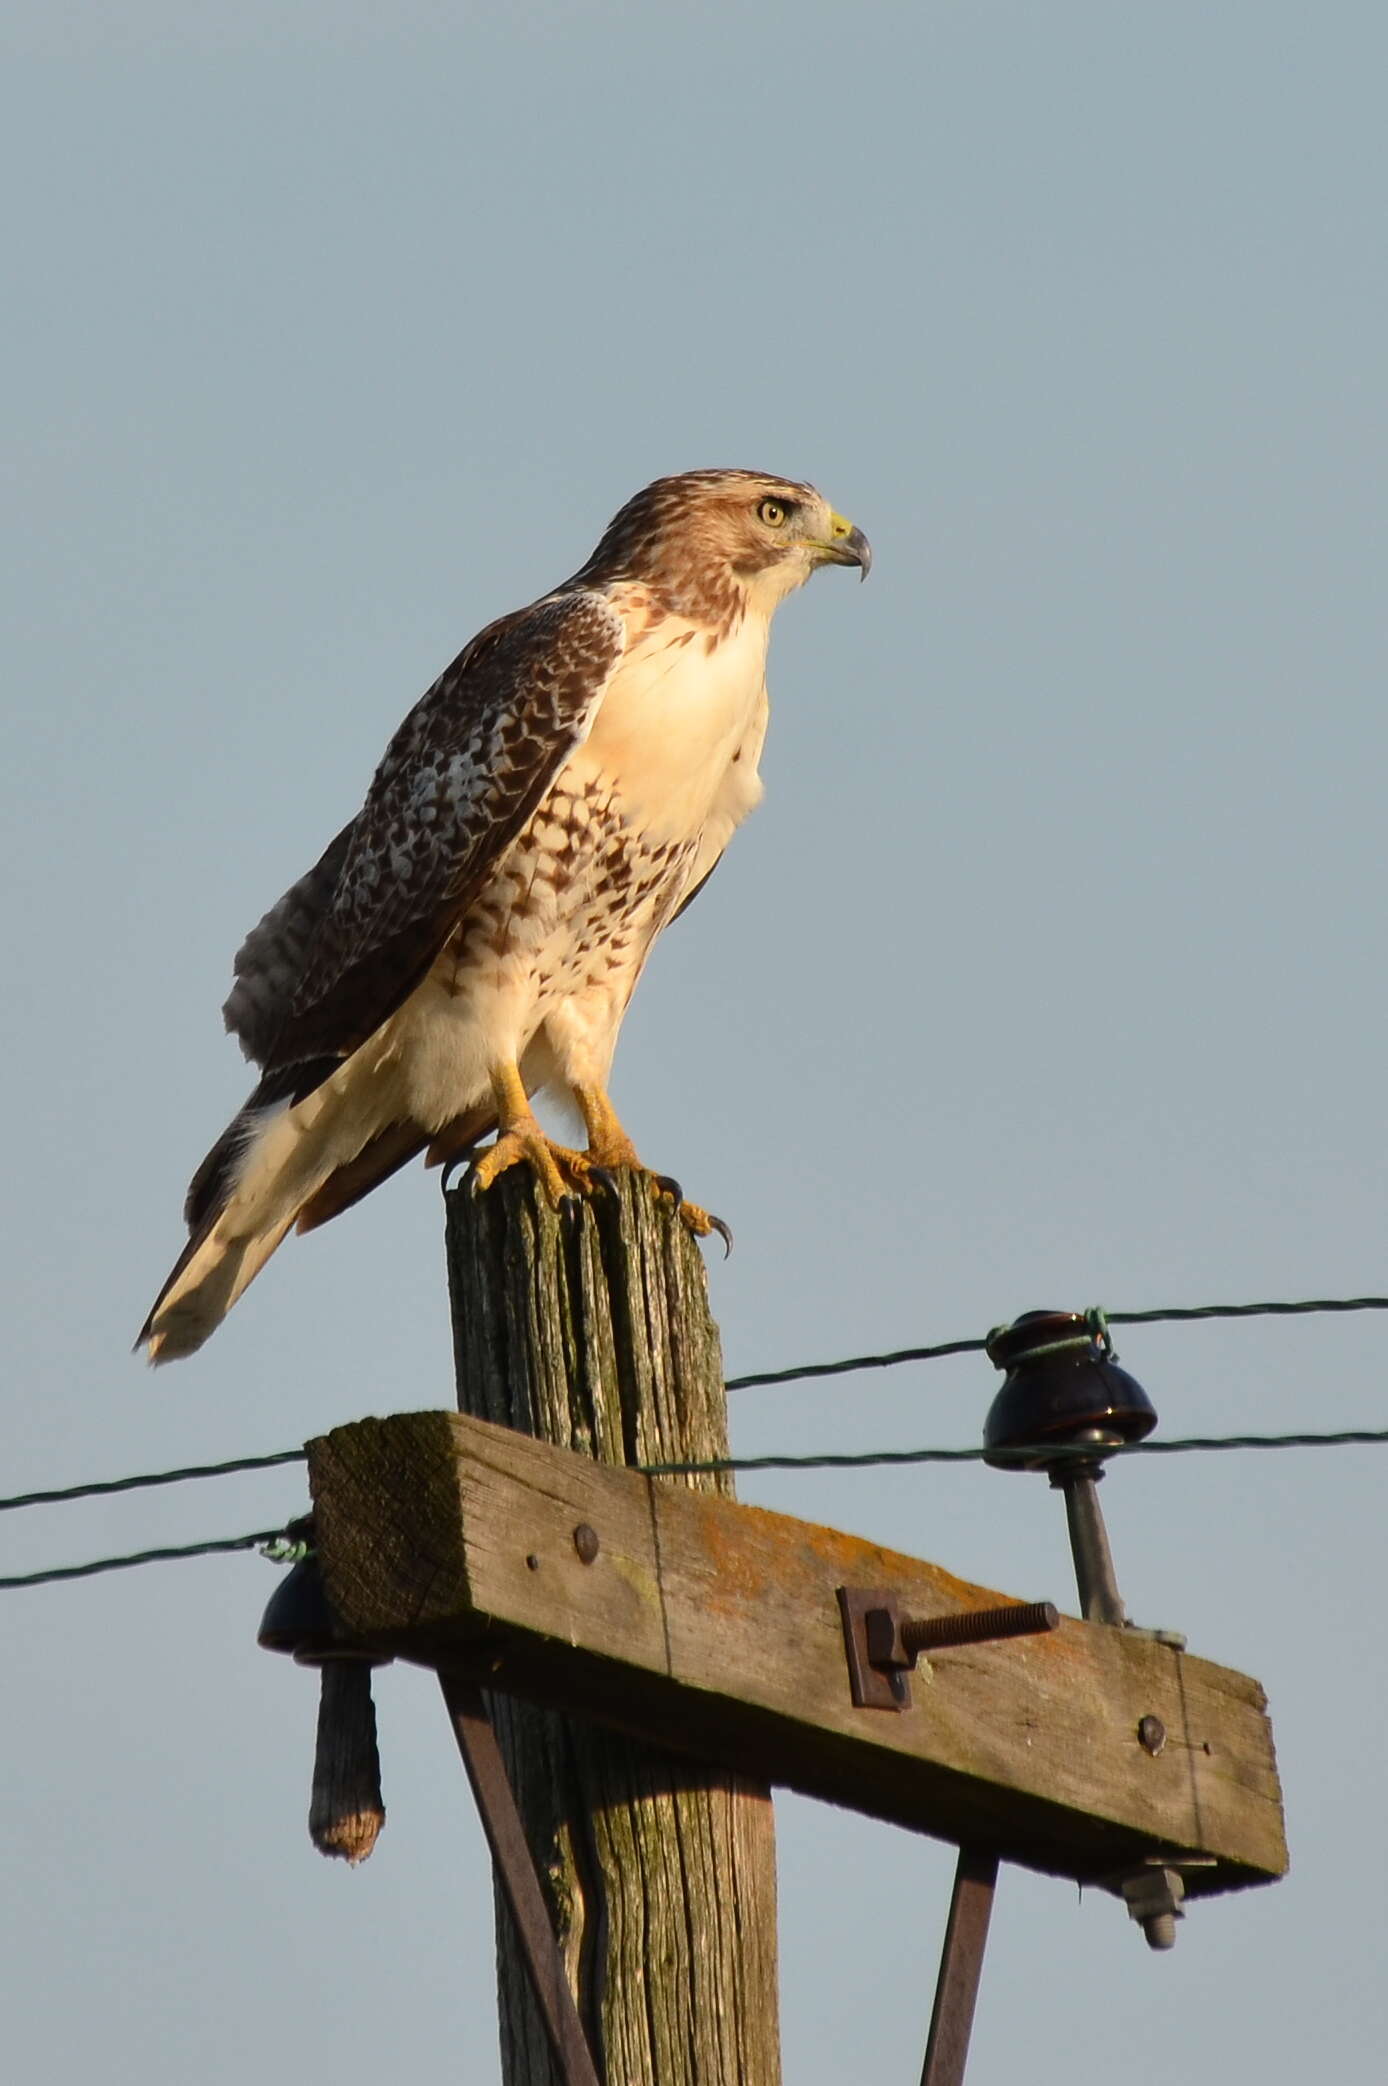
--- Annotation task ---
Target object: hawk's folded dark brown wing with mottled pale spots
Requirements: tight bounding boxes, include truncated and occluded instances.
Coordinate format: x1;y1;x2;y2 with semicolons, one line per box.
240;590;622;1070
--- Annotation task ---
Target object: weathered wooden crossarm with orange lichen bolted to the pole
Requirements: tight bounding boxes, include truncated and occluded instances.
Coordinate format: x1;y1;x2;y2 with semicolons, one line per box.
309;1412;1286;1894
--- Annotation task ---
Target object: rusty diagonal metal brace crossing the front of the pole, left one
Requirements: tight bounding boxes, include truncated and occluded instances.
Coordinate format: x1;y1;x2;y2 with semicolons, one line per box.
438;1669;601;2086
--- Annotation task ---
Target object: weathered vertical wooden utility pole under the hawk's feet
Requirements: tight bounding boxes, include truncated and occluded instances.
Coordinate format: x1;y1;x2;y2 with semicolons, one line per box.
449;1170;781;2086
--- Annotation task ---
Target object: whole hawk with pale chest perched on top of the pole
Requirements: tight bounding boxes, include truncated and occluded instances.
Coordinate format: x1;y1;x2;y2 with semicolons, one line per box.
140;471;870;1362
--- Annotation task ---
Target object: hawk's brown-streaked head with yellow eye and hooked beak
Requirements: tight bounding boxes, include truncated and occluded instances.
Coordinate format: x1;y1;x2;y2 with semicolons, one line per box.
578;471;872;624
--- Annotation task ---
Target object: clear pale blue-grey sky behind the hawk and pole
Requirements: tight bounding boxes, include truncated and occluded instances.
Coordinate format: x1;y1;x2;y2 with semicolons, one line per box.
0;0;1388;2086
